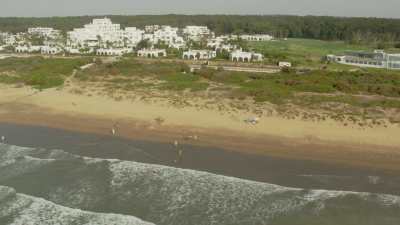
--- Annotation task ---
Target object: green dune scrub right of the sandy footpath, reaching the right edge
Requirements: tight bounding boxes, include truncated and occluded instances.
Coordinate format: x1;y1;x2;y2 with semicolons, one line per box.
75;58;400;111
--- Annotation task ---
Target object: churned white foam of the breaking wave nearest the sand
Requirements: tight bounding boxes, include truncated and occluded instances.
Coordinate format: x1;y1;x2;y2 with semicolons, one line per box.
0;144;400;224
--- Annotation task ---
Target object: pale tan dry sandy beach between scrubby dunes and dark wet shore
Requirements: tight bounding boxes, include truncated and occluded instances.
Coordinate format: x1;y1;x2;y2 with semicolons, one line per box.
0;86;400;171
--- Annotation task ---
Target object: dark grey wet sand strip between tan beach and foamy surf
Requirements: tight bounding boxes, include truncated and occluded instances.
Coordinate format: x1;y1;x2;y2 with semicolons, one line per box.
0;123;400;195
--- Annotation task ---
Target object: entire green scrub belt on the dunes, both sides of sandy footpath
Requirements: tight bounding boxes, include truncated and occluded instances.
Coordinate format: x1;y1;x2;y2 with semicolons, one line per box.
0;57;400;108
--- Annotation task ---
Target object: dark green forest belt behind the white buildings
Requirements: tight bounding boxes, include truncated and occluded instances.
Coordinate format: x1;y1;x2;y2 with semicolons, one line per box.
0;15;400;42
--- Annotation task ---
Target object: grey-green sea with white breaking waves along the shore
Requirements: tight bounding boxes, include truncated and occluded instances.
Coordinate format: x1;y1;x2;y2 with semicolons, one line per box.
0;144;400;225
